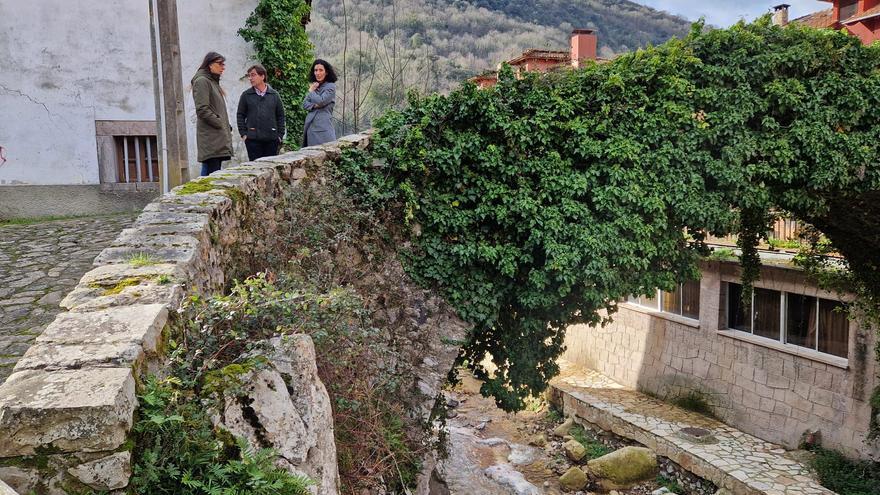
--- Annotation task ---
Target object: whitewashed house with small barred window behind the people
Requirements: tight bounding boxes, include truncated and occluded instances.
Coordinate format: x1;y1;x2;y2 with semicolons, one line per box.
0;0;282;219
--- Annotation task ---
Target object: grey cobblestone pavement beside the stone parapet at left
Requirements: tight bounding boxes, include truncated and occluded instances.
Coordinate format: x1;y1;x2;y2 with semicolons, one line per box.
0;213;137;383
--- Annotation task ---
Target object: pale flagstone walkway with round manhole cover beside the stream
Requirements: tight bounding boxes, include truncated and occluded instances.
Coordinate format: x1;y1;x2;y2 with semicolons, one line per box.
551;361;834;495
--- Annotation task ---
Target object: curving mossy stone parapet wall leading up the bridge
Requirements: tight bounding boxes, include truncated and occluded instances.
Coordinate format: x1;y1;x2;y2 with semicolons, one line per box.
0;134;382;493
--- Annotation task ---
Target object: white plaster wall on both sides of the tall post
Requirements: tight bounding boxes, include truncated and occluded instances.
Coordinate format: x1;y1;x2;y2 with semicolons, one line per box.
0;0;258;186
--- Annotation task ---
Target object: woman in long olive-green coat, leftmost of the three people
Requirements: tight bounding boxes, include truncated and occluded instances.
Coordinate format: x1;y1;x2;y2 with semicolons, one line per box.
192;52;232;176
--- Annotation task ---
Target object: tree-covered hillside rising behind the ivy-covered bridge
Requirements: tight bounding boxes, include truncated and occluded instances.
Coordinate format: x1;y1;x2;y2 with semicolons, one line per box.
307;0;689;132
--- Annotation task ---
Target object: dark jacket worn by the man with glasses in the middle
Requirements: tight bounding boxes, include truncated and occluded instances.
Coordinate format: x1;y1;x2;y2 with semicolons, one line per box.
236;86;284;141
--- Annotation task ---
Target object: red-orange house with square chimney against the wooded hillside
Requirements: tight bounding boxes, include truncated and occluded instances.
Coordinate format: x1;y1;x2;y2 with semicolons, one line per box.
470;29;598;88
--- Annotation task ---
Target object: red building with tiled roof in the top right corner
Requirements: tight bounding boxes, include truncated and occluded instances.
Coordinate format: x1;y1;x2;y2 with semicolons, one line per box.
774;0;880;45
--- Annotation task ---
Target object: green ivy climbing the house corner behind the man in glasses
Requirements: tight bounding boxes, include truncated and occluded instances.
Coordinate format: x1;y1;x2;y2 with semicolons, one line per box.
238;0;314;149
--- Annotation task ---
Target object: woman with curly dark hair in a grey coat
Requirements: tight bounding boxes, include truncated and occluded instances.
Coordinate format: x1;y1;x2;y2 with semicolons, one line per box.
303;59;336;146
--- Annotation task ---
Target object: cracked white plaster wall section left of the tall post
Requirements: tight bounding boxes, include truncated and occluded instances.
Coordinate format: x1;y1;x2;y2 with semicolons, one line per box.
0;0;156;185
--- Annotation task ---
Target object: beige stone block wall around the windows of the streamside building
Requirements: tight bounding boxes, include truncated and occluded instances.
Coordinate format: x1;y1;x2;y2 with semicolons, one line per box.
563;262;880;459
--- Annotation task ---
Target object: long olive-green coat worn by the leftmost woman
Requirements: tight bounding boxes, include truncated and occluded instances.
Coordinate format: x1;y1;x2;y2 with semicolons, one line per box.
192;69;232;162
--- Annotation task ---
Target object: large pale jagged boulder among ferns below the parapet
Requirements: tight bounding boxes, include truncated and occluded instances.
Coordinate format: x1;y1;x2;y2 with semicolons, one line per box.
217;335;339;495
